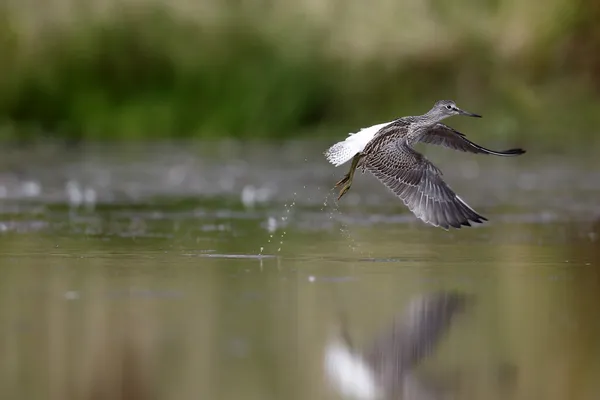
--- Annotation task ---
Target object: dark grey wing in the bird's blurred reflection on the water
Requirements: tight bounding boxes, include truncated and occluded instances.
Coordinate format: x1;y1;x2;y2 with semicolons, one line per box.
365;291;475;393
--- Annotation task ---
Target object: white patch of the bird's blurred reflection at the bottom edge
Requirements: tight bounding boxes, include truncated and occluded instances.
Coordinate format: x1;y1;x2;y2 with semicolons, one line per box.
325;339;380;400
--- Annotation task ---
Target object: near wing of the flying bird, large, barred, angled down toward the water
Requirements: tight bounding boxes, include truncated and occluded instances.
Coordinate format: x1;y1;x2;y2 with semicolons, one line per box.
363;135;487;229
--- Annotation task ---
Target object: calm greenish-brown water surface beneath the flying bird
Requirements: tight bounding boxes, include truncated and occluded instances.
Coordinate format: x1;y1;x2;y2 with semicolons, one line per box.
0;142;600;400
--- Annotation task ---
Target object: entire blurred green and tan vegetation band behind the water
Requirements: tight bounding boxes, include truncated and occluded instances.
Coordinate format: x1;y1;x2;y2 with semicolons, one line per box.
0;0;600;143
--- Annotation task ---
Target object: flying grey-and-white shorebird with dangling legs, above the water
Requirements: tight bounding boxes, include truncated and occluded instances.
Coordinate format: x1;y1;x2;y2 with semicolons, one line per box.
325;100;525;230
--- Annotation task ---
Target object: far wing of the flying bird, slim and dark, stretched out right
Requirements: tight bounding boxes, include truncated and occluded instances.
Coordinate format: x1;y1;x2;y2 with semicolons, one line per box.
420;123;525;156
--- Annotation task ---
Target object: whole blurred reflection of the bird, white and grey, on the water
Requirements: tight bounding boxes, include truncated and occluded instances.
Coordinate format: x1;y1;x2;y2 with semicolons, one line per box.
323;290;476;400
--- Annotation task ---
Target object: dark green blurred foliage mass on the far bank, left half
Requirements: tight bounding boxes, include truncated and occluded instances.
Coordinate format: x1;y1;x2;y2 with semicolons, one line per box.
0;8;338;138
